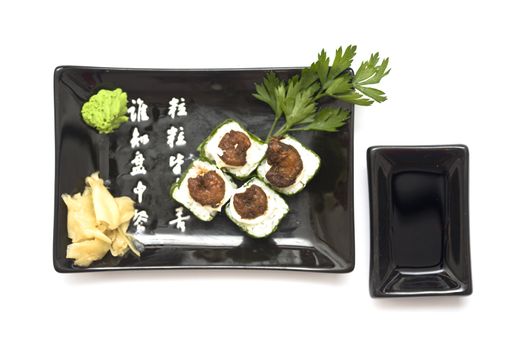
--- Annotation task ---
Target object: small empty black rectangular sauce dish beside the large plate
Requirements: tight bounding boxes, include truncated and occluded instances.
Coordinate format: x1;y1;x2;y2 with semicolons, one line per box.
367;145;472;297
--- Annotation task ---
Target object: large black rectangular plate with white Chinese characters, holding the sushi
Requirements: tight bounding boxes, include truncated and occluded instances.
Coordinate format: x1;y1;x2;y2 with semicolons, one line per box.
53;66;354;272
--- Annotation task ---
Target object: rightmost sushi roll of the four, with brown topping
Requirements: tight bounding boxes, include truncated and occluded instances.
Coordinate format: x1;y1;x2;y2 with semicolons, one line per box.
257;135;321;195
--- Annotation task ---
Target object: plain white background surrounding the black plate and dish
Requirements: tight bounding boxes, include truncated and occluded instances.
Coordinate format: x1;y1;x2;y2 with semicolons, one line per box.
0;0;525;349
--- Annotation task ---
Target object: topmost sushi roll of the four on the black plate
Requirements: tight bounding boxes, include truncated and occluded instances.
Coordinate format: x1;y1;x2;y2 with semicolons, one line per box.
197;119;267;180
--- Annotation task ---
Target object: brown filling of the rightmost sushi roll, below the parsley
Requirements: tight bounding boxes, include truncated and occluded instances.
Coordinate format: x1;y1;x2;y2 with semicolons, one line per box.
266;137;303;187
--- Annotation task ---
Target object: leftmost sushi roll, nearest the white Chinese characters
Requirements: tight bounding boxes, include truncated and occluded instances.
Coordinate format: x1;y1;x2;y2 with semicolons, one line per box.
171;160;237;221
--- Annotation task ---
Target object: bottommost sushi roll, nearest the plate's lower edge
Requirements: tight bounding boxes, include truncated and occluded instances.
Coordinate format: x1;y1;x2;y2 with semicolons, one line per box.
225;178;289;238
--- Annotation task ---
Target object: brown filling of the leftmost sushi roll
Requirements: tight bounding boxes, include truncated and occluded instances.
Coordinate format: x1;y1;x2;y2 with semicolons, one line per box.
188;170;226;207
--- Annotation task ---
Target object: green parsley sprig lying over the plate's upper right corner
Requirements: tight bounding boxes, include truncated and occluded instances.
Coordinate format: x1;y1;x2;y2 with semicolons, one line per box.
253;45;390;141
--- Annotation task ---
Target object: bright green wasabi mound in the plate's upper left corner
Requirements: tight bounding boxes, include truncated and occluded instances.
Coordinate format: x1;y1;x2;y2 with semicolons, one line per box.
81;89;128;134
